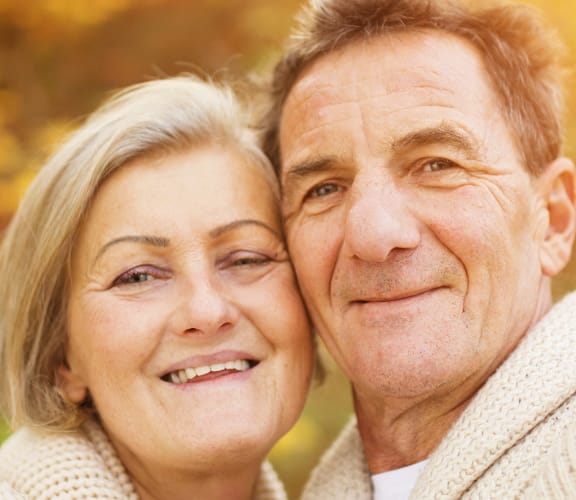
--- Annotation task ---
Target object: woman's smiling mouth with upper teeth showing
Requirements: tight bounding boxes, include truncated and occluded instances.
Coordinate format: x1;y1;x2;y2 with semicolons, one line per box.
160;351;259;385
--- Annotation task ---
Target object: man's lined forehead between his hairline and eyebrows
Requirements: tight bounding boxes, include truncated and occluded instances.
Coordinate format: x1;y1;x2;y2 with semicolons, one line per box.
280;32;508;176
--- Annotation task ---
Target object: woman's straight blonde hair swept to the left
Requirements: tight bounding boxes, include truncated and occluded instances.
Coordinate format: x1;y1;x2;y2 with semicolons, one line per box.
0;76;277;429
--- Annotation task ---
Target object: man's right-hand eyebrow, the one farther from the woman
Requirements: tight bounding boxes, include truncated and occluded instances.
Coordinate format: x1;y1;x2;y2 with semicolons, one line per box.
391;124;481;157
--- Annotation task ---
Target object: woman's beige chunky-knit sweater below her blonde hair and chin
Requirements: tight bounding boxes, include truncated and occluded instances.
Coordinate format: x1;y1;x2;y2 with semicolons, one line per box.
0;422;286;500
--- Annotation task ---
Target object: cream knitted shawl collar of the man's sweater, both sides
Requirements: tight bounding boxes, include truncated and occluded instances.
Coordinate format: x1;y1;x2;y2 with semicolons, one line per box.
302;292;576;500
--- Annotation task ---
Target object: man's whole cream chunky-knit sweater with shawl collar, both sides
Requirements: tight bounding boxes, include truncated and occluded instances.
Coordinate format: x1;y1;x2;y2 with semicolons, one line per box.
302;293;576;500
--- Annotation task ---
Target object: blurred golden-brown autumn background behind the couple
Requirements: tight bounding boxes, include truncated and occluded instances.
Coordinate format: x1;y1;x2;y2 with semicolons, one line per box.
0;0;576;498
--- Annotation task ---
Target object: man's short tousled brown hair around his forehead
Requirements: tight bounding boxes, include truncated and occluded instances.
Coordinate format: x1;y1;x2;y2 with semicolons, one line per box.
264;0;565;175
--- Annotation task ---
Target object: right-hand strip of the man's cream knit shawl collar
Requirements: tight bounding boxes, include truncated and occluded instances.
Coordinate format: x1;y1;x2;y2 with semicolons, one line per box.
413;293;576;498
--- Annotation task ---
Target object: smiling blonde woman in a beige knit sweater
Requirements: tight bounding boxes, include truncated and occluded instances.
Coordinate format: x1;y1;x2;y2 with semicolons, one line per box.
0;77;313;500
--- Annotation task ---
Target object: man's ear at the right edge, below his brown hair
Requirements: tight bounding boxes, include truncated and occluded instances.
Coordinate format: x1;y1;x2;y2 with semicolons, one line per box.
539;158;576;276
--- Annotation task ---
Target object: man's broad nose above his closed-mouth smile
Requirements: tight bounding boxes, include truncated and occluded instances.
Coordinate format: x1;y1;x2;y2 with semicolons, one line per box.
344;176;421;262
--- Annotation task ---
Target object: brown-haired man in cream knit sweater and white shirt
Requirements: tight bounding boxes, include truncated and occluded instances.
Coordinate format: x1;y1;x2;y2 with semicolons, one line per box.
266;0;576;499
